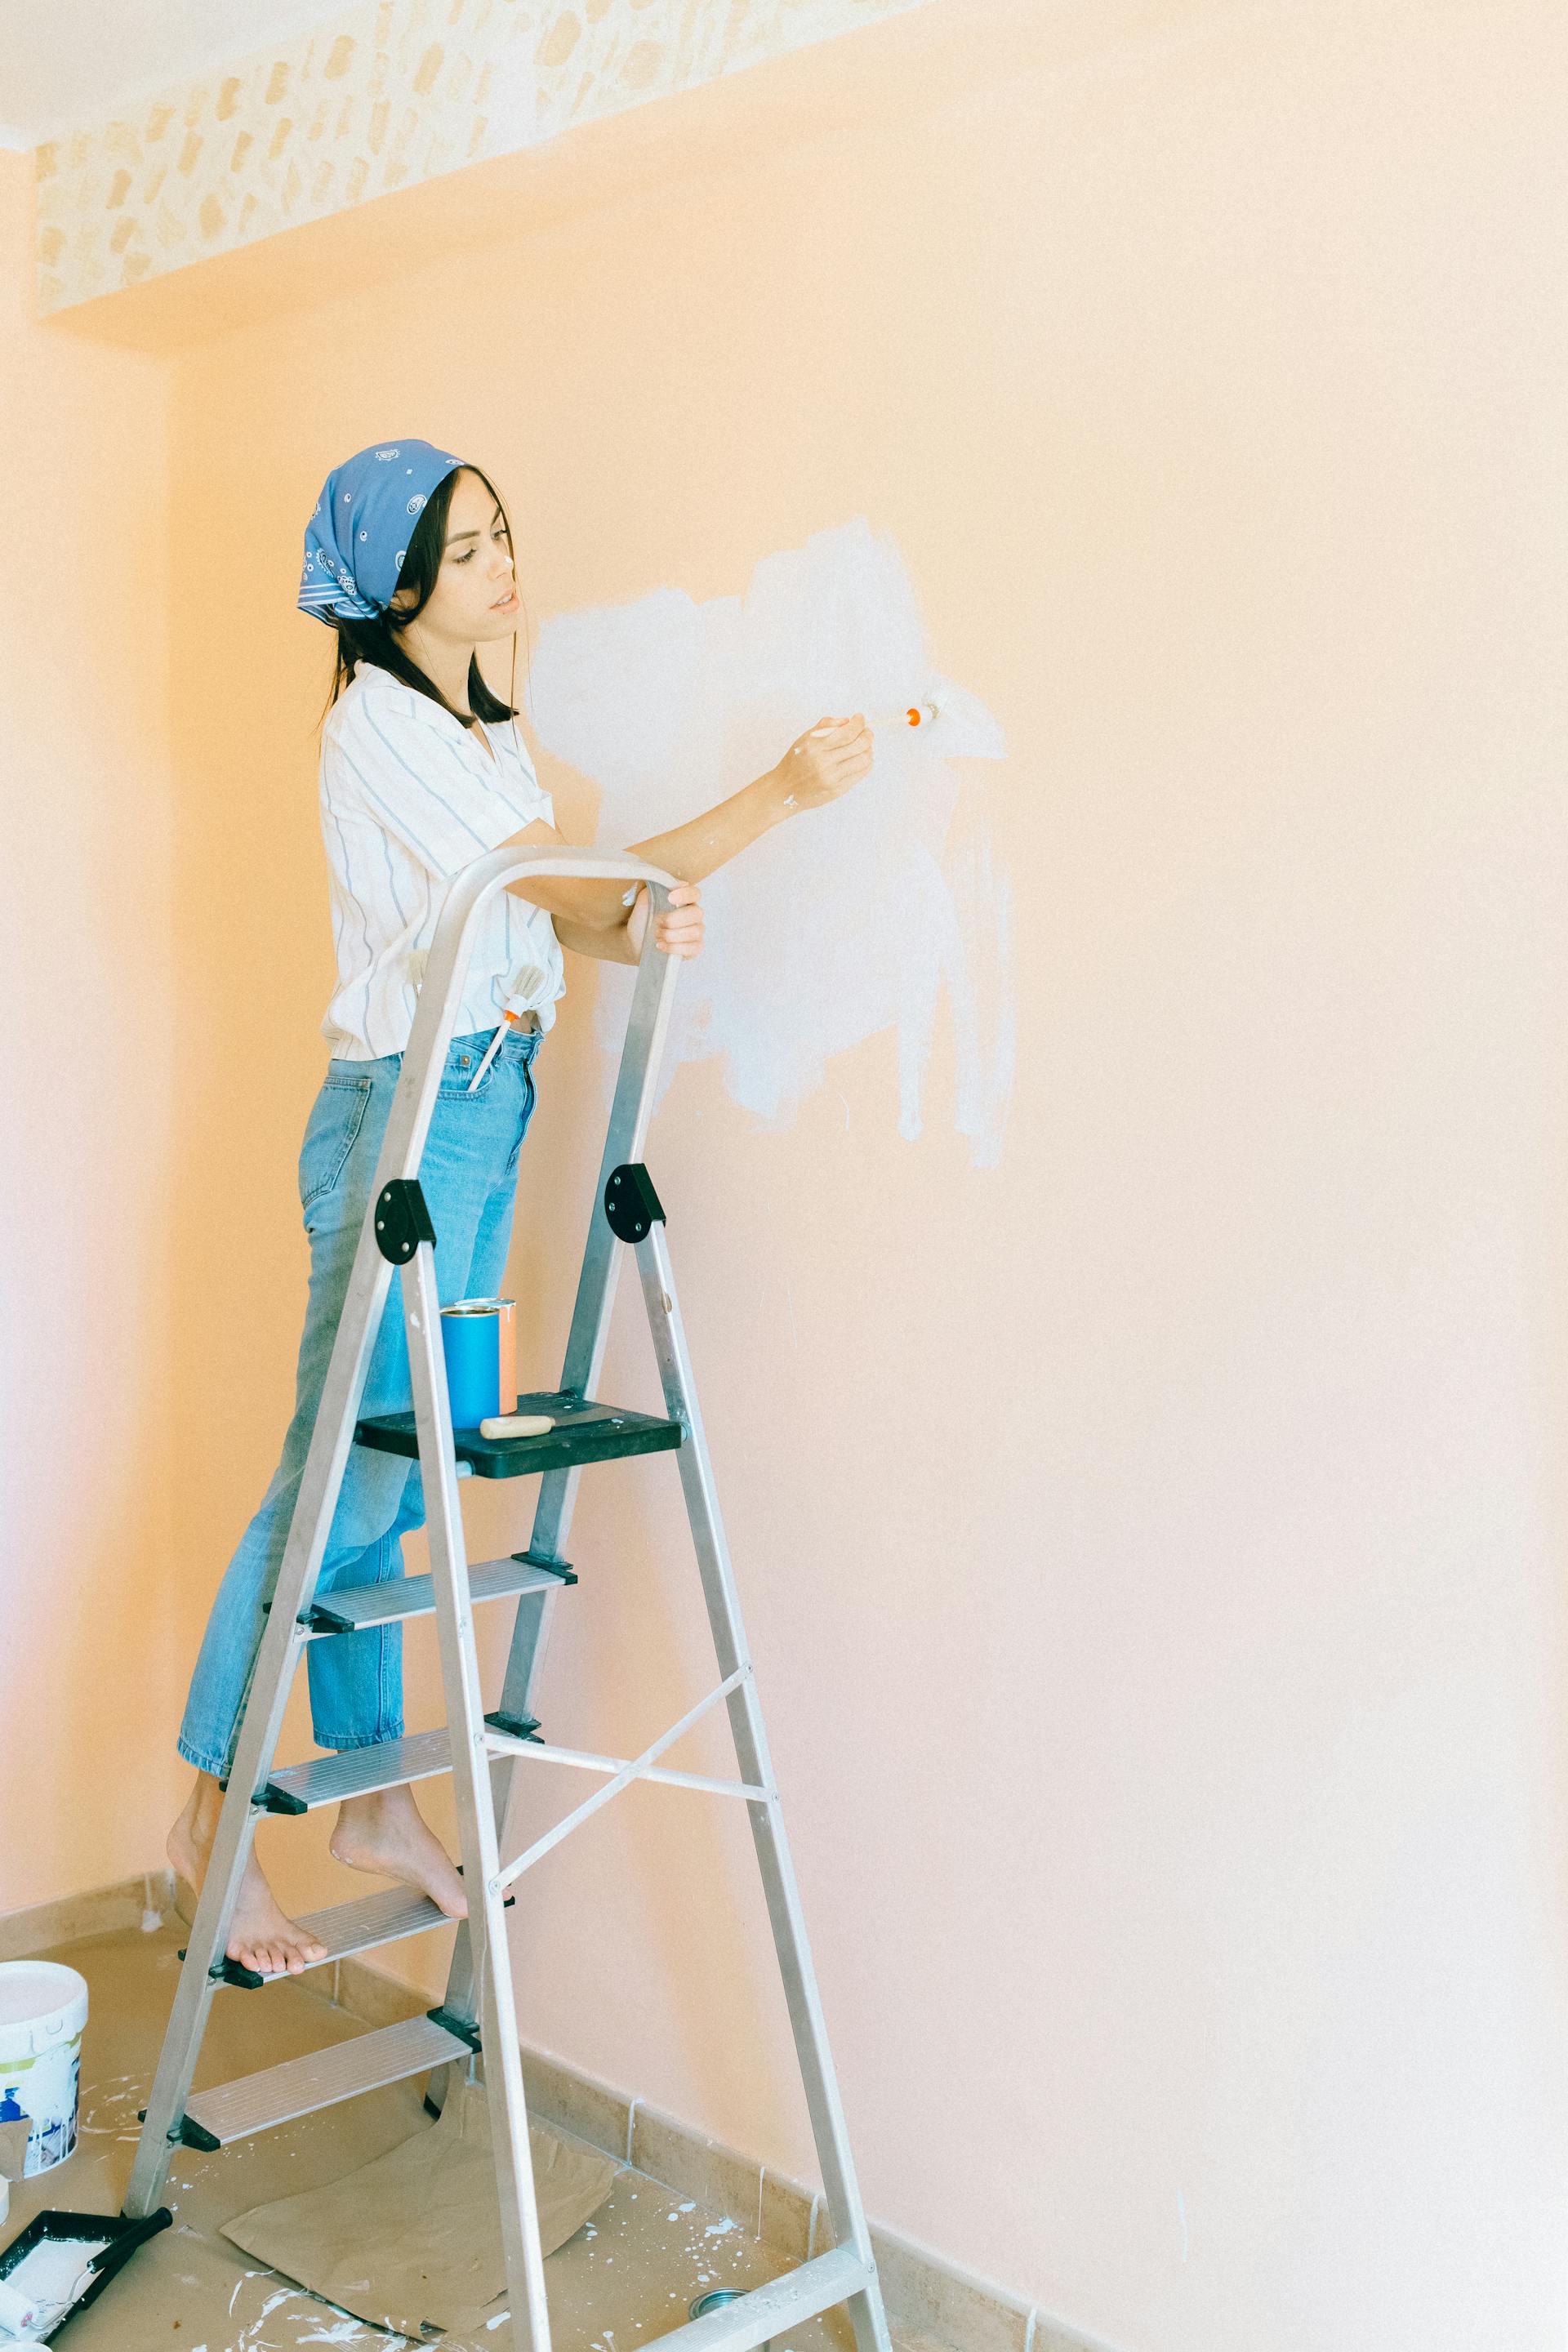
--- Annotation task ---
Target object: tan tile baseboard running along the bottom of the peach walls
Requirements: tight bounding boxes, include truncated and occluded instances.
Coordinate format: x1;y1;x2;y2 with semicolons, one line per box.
0;1870;1116;2352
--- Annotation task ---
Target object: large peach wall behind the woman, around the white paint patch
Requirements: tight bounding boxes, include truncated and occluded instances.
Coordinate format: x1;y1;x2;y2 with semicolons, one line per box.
24;0;1568;2352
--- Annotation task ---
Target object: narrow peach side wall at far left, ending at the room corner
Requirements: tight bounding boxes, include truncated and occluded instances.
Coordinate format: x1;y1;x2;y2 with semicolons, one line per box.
0;153;181;1910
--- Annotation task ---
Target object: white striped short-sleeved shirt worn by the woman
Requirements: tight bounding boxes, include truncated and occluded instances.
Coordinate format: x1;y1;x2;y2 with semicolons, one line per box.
319;661;567;1061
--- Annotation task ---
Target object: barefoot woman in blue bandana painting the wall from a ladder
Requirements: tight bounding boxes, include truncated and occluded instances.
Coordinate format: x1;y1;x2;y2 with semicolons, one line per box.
169;440;872;1976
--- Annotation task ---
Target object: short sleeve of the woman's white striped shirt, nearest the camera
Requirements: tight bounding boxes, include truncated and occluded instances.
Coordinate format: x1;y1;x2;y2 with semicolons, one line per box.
324;687;548;880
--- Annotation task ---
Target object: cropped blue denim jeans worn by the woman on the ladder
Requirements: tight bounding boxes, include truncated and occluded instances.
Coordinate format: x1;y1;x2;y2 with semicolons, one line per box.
179;1030;538;1778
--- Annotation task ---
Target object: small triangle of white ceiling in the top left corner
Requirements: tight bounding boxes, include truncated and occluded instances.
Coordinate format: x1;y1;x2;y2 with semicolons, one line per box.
0;0;359;148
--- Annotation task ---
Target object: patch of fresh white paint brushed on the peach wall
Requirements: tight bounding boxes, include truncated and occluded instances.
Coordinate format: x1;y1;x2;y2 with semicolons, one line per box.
529;519;1013;1166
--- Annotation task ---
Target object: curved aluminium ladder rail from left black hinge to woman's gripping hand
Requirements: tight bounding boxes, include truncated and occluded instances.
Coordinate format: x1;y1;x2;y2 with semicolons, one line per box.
374;847;677;1195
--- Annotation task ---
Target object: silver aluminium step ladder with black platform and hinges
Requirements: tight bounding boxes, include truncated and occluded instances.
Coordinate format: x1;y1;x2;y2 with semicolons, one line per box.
125;849;889;2352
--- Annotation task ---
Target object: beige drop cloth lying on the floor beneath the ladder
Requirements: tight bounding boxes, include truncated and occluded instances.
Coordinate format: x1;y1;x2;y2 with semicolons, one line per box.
223;2082;623;2338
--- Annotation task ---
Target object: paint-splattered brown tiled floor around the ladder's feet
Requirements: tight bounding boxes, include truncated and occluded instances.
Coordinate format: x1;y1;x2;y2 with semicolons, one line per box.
0;1924;870;2352
